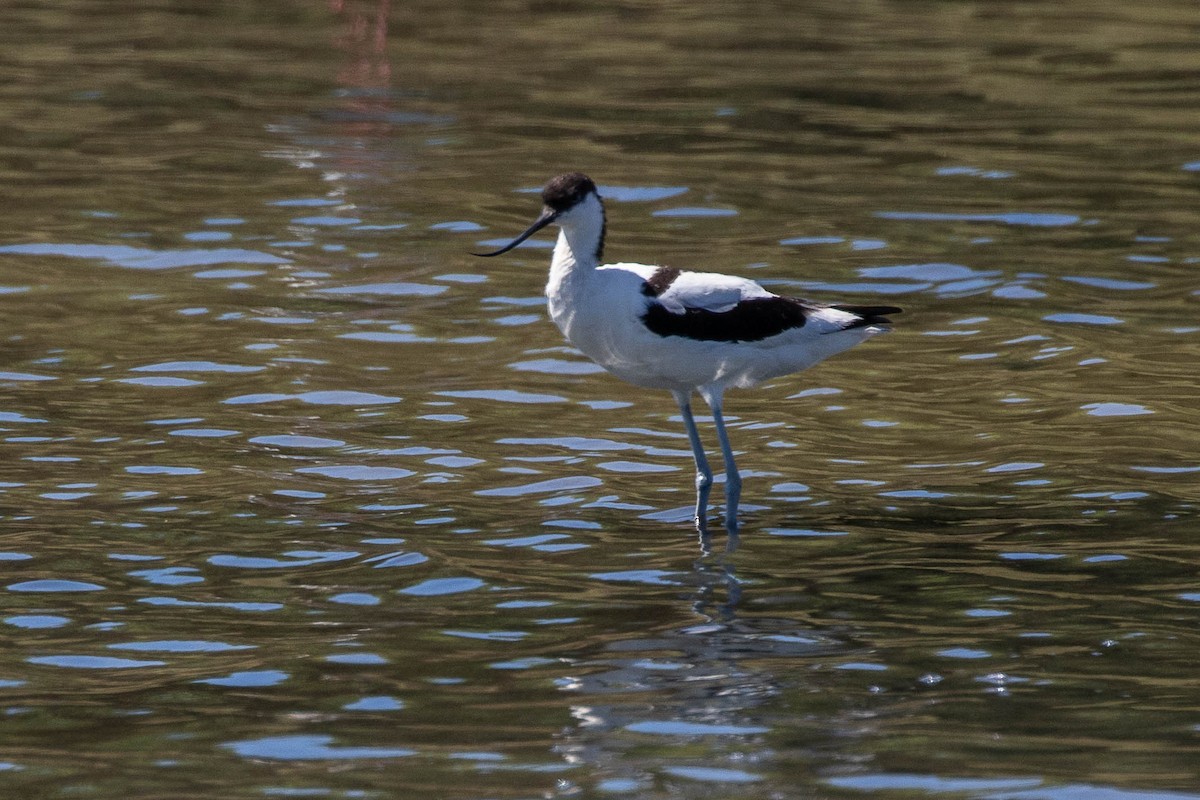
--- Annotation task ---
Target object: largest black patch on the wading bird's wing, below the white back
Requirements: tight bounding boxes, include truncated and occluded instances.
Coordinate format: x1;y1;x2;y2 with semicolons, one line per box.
642;297;815;342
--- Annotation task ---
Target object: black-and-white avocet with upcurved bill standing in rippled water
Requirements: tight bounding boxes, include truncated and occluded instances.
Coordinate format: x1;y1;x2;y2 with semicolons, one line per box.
474;173;900;535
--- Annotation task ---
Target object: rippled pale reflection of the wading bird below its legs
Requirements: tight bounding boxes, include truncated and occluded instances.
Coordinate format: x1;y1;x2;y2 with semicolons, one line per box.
556;537;852;794
